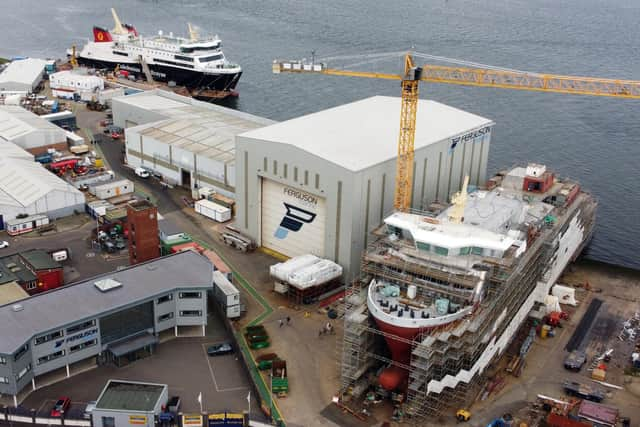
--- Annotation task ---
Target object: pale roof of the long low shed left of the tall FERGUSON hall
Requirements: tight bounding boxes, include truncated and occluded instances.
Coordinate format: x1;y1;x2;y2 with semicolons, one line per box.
125;90;274;163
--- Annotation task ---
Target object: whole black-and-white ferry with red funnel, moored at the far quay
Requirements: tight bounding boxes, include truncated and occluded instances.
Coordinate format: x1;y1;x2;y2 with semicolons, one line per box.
77;9;242;91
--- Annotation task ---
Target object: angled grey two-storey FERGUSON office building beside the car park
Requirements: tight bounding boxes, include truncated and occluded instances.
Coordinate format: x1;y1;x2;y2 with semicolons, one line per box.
0;251;213;405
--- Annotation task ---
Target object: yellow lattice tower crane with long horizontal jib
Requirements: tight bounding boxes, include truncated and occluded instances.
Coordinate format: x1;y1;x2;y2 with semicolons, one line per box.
273;53;640;211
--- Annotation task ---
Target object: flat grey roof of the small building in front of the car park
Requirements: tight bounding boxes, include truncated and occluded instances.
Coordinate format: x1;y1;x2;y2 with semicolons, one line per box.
96;380;167;412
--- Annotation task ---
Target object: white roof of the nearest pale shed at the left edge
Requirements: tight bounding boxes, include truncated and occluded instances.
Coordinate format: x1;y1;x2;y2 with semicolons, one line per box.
0;157;84;208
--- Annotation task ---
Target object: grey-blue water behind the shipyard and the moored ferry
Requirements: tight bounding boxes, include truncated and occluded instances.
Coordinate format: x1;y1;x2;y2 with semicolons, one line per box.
0;0;640;268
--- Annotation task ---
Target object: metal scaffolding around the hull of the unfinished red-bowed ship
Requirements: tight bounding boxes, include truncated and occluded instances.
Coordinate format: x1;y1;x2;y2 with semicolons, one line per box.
339;190;596;420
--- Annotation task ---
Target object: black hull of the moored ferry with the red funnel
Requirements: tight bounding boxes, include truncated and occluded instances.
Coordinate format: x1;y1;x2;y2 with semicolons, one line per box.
78;56;242;91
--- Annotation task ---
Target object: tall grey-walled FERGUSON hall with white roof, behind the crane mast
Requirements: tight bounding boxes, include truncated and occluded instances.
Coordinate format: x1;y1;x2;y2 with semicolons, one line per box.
235;96;494;280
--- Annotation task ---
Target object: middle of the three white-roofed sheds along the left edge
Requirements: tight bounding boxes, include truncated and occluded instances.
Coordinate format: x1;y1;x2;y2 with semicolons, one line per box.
0;105;67;154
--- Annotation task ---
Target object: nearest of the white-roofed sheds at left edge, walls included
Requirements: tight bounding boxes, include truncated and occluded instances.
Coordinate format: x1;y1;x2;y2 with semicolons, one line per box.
0;156;85;229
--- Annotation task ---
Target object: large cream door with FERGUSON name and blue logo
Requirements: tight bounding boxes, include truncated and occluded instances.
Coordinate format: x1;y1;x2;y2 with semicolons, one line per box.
261;178;327;257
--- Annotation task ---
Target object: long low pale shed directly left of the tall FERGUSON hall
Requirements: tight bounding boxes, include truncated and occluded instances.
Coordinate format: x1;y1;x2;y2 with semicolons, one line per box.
112;90;274;197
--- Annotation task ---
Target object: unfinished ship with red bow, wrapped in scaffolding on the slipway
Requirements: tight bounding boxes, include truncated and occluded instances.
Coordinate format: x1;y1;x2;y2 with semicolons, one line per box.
341;164;597;418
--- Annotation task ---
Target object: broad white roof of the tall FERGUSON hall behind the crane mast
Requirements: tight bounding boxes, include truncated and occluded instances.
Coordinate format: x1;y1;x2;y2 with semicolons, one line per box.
240;96;494;171
